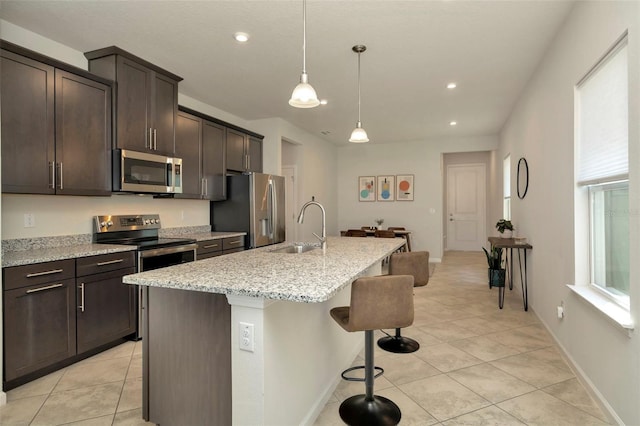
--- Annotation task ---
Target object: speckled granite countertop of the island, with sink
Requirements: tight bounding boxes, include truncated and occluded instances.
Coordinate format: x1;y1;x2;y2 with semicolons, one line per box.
123;237;405;303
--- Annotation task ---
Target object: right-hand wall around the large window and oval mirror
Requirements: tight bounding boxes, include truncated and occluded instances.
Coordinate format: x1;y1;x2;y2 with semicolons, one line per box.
500;2;640;424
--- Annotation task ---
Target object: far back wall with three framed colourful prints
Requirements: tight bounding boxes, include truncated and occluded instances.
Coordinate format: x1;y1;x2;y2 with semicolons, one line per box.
338;136;498;261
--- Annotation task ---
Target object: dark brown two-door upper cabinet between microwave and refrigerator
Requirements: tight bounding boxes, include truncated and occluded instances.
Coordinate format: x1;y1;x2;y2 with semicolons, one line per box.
175;107;226;201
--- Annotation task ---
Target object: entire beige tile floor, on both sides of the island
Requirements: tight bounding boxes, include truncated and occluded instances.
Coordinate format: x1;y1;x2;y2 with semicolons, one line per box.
0;252;608;426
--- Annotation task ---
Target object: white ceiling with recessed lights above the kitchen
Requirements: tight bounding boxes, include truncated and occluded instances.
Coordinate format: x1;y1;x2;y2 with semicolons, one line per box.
0;0;573;145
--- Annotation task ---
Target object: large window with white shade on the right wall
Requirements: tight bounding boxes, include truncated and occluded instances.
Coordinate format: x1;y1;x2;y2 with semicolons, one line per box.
576;36;629;307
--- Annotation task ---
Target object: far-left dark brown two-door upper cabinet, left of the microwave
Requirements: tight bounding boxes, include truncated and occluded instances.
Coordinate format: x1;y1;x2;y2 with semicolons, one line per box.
0;41;112;195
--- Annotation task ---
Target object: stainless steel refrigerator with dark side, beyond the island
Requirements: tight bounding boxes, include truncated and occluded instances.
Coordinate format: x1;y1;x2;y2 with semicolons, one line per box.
211;173;285;249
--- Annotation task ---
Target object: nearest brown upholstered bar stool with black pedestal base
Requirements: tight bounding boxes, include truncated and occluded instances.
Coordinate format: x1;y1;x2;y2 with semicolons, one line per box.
330;275;413;426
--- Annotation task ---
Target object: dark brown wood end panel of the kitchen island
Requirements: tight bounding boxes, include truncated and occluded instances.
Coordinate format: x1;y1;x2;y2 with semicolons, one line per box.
143;287;231;426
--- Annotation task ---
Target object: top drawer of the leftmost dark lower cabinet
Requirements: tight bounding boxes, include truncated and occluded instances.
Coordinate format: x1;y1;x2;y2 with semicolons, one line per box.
2;259;76;290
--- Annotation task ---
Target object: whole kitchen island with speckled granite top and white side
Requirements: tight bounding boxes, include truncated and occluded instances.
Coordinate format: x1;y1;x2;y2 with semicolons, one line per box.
124;237;404;425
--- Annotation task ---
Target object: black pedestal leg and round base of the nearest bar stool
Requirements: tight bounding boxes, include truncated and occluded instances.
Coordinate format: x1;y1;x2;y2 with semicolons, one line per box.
340;330;402;426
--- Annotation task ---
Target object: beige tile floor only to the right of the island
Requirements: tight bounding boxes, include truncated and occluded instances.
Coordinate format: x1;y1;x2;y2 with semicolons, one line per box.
315;252;609;426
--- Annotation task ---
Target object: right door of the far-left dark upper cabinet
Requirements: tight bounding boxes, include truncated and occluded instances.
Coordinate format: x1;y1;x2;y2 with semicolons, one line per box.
55;70;111;195
